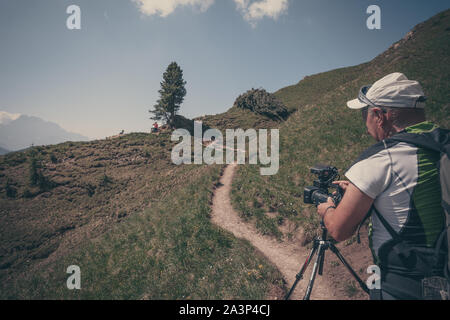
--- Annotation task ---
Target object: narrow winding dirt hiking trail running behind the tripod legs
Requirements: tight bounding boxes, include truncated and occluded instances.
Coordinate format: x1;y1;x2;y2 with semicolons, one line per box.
211;163;336;300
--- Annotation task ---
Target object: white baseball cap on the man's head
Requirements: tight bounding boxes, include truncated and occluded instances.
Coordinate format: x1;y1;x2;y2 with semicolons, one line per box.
347;72;426;109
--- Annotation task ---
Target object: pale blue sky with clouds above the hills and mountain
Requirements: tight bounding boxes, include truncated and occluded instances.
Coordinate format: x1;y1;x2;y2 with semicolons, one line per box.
0;0;450;138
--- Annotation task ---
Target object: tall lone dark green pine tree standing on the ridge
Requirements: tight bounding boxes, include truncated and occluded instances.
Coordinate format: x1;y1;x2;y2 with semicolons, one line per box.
149;62;186;128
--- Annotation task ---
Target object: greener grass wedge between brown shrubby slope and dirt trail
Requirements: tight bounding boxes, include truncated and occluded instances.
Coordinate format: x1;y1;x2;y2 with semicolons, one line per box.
0;166;283;299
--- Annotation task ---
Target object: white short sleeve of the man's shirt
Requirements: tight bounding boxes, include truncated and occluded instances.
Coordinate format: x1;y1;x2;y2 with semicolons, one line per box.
345;150;391;200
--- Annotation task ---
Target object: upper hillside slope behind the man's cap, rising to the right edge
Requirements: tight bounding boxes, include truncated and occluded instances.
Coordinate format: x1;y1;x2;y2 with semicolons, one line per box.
275;10;450;127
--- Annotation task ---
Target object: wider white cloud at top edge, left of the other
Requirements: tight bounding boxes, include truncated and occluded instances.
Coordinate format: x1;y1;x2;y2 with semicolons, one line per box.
132;0;214;17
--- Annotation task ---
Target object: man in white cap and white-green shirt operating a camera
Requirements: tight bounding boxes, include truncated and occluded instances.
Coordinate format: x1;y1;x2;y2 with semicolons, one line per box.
318;73;445;299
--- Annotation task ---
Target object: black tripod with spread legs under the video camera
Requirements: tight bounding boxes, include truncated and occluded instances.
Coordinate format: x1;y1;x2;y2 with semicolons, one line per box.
285;221;369;300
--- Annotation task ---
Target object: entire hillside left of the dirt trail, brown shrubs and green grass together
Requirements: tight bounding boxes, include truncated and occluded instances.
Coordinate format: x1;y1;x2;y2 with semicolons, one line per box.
0;134;283;299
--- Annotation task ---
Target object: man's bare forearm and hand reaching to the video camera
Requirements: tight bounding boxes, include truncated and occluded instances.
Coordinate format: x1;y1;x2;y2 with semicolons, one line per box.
317;183;373;241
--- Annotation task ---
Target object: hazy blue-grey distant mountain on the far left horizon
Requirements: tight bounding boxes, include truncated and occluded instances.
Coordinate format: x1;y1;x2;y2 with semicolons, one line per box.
0;111;89;152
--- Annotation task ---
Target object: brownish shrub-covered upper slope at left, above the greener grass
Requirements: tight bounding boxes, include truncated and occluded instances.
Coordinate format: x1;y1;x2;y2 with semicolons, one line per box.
0;134;191;278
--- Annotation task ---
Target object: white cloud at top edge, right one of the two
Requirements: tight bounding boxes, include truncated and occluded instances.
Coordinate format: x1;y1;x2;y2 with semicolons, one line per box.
234;0;288;26
